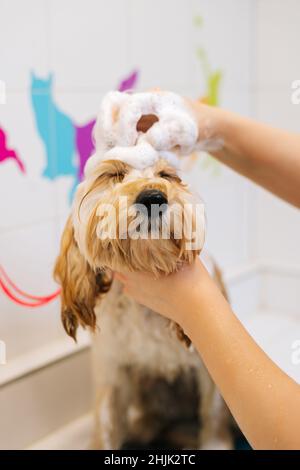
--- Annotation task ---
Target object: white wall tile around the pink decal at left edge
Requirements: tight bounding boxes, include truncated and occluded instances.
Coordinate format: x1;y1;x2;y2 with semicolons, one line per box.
0;92;57;229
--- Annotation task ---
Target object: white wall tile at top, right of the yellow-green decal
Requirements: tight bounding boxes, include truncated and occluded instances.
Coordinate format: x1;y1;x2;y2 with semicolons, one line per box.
186;0;255;92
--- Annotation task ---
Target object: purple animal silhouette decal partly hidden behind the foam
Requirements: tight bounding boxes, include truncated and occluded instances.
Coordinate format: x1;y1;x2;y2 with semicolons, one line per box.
74;70;138;181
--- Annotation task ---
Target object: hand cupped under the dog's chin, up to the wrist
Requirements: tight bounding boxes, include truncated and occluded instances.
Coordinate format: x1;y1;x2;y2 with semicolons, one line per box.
115;259;214;327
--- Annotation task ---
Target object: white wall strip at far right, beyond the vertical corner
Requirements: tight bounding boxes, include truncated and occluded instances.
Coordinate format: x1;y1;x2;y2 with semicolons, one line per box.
256;0;300;266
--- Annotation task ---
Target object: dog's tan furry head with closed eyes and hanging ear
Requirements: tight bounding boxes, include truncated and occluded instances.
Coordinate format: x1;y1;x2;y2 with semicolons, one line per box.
55;150;204;337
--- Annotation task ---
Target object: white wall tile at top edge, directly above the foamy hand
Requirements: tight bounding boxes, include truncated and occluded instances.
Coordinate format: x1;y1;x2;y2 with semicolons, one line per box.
129;0;194;92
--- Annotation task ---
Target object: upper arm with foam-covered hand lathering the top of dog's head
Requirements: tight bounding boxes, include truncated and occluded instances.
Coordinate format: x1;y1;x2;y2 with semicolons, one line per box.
99;90;300;207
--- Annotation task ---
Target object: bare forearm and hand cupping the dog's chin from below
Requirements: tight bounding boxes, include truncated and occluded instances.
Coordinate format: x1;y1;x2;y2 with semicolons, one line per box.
117;260;300;449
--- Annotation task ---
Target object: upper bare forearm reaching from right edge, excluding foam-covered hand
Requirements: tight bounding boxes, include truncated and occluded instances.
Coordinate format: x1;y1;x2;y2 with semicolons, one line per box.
194;103;300;207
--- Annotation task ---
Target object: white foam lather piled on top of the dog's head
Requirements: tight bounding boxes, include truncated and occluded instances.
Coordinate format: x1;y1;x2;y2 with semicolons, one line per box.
86;91;198;172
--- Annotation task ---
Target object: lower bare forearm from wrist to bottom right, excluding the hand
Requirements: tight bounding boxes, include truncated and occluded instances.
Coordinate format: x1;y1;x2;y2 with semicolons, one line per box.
179;267;300;449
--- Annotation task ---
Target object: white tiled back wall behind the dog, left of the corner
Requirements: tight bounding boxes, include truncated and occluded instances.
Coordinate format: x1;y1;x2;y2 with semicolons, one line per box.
0;0;255;364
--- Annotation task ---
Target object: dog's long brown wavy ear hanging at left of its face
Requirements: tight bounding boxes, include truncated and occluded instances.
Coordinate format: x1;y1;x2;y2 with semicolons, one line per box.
54;218;111;340
